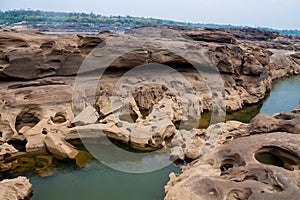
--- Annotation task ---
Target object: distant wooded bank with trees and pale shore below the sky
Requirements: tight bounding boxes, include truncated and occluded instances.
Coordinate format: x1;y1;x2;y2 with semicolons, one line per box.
0;10;300;35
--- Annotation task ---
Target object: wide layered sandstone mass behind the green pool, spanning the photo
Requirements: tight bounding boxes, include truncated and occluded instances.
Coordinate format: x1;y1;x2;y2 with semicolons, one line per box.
0;27;300;173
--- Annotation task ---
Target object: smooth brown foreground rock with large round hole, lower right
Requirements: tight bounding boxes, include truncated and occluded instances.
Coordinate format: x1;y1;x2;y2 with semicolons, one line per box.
165;133;300;200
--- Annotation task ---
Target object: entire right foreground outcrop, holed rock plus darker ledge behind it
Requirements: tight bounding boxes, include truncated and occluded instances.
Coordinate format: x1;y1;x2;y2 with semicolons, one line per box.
165;107;300;200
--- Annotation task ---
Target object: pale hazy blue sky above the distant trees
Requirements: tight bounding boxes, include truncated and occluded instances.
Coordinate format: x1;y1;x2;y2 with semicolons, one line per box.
0;0;300;29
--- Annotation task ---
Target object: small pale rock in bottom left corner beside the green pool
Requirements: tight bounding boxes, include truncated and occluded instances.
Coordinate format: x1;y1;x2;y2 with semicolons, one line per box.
0;176;32;200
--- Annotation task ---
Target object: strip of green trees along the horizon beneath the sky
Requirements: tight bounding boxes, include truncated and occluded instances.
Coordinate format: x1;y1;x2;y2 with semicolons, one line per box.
0;9;300;35
